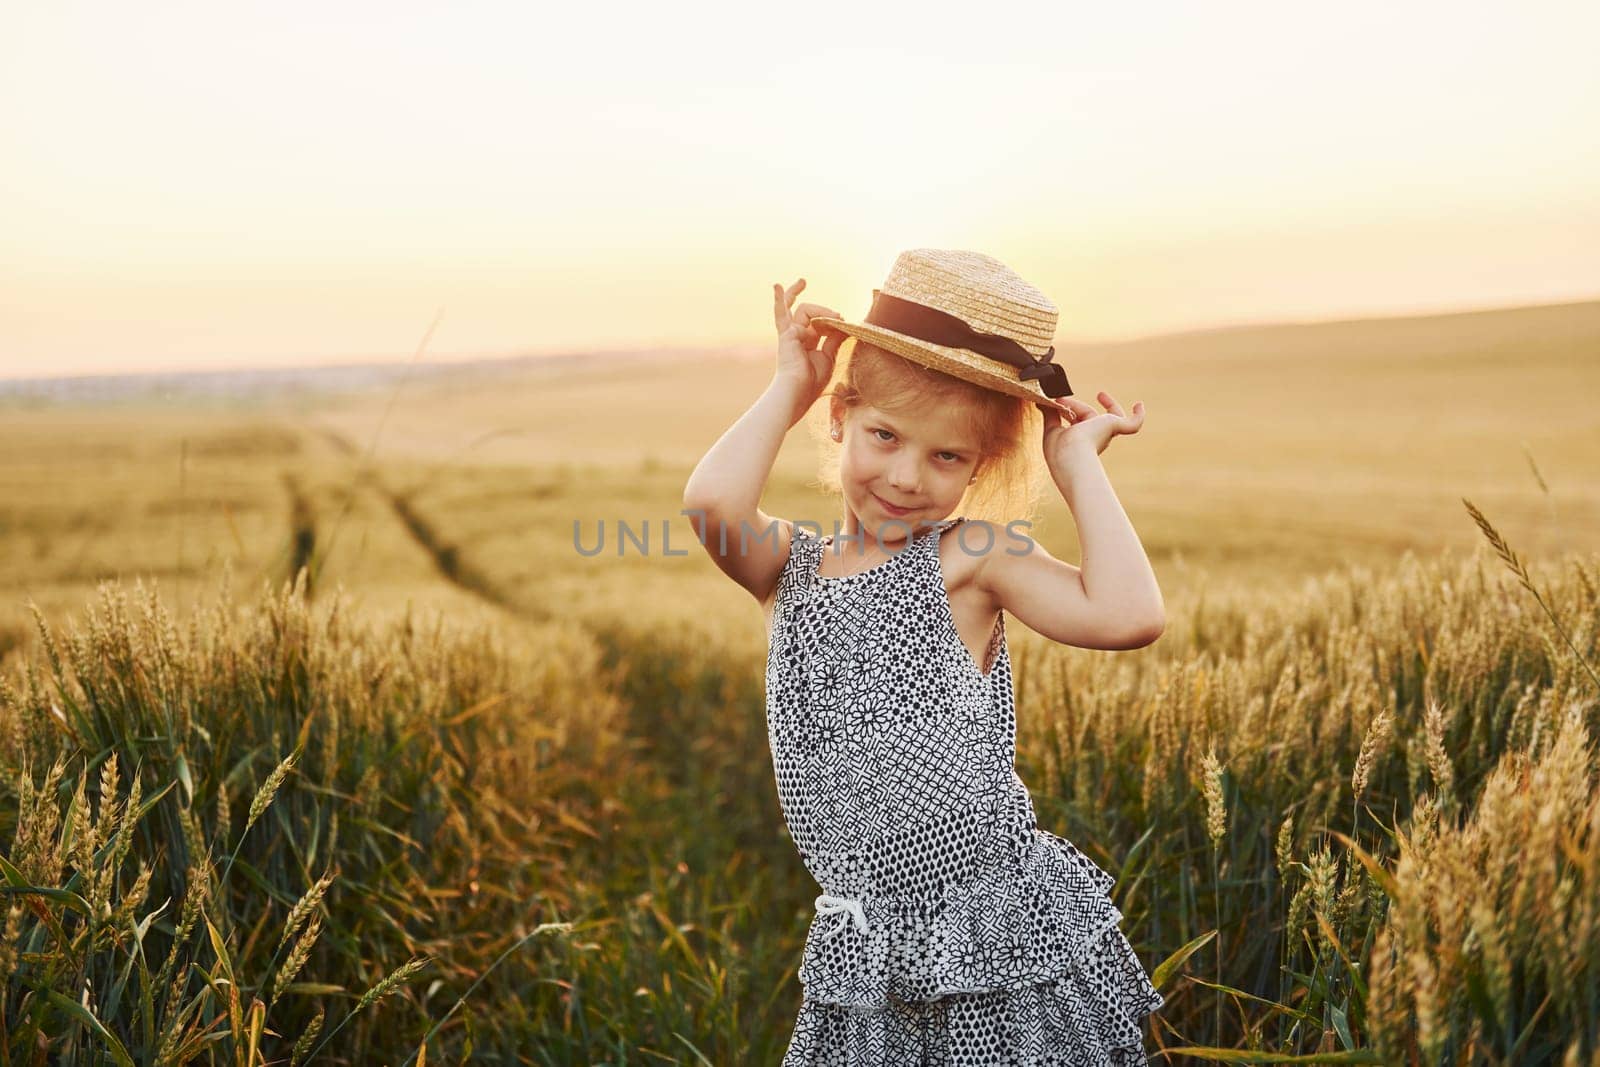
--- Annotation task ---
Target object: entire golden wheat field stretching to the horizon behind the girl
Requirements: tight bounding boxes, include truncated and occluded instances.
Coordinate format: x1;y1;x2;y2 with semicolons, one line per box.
0;295;1600;1064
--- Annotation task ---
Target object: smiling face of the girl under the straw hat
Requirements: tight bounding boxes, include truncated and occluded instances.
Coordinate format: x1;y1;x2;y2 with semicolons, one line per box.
838;405;978;541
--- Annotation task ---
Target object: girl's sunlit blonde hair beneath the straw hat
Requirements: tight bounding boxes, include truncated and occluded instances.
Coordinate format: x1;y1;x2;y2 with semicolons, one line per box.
808;338;1048;526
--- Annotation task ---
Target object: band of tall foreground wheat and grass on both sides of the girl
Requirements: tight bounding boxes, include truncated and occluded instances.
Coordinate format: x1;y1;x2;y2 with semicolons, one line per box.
0;520;1600;1064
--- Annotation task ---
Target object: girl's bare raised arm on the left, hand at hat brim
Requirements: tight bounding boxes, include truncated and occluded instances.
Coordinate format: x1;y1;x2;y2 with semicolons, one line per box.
683;278;843;605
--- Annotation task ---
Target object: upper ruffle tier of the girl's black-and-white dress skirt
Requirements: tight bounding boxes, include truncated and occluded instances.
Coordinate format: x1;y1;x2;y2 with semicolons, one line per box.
798;827;1163;1014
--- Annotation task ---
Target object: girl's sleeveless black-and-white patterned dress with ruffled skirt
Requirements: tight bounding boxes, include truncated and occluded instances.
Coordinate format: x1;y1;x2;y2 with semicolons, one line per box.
766;518;1165;1067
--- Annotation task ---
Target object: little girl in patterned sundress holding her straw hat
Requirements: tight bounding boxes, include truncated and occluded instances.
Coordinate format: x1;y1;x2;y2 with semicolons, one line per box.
683;250;1165;1067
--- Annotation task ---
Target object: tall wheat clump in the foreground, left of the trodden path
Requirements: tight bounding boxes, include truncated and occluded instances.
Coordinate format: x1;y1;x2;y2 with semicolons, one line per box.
0;569;614;1062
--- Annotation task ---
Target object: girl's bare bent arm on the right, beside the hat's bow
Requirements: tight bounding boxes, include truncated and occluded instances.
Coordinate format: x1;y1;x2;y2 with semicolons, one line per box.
974;402;1166;649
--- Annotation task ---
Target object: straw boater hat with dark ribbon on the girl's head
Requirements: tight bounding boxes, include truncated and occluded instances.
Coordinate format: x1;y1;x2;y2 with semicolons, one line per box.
811;248;1072;400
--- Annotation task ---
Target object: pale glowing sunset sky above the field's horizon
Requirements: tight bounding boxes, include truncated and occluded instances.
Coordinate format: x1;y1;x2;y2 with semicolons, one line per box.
0;0;1600;378
